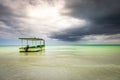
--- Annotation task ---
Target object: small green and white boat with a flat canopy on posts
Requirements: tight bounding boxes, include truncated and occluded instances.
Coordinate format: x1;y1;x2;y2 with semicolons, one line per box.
19;38;45;52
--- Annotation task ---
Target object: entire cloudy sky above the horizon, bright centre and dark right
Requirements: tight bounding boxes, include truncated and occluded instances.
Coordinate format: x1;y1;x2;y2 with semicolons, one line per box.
0;0;120;45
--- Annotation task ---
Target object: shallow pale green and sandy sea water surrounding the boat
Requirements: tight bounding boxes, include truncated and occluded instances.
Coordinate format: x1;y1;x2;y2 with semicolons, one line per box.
0;45;120;80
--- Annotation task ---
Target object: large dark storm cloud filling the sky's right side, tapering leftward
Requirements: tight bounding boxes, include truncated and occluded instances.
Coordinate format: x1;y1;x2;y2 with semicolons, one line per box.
50;0;120;41
